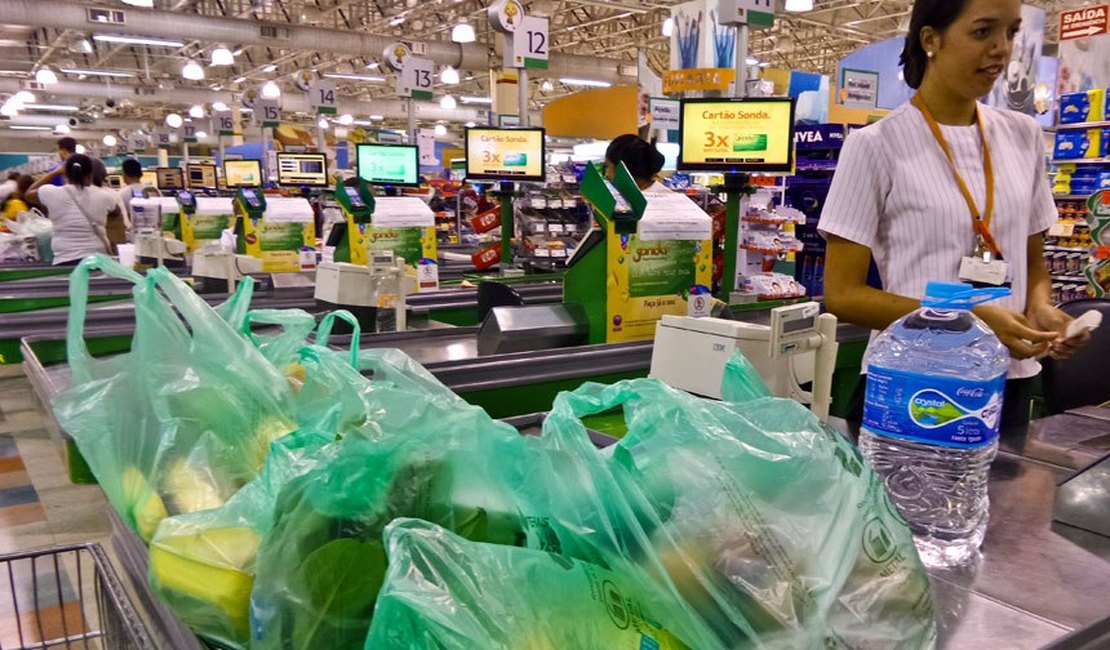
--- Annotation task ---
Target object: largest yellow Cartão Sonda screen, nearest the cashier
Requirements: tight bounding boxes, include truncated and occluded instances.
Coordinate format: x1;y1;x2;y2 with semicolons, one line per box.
678;98;794;172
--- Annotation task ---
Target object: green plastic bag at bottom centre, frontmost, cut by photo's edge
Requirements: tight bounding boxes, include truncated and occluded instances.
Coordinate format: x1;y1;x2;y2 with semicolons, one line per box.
365;519;701;650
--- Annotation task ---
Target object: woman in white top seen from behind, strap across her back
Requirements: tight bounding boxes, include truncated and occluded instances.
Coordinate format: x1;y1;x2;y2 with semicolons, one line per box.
27;153;115;265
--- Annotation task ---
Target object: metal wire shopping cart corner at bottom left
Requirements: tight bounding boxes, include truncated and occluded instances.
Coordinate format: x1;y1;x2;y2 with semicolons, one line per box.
0;544;154;650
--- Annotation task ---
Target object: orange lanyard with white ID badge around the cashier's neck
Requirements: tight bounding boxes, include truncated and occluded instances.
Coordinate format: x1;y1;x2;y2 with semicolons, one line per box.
912;93;1010;286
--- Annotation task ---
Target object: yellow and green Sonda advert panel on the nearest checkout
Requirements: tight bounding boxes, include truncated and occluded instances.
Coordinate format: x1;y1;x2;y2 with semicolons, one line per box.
606;225;713;343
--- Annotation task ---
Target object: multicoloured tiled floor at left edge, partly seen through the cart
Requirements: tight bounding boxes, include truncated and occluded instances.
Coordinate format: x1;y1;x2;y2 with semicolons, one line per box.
0;366;110;648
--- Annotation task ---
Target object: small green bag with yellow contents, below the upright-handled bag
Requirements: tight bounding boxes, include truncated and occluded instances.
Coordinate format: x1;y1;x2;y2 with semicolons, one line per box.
150;431;332;649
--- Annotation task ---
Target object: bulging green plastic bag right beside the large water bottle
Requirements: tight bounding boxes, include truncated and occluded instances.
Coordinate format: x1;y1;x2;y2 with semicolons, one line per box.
544;364;936;648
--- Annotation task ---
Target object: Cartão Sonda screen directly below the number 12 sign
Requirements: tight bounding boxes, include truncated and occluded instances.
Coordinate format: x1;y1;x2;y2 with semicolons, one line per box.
466;129;544;181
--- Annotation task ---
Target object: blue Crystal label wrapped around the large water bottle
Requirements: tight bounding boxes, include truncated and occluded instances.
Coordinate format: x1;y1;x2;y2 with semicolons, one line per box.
864;366;1006;447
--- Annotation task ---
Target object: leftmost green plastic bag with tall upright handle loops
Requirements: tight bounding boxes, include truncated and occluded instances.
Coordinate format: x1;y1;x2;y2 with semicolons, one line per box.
52;255;296;541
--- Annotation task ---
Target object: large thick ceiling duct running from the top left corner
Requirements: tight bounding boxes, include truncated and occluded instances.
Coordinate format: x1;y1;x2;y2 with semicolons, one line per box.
0;0;627;81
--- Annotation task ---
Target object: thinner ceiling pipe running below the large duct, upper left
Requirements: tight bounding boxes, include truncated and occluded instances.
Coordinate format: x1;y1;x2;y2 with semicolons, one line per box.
0;79;484;122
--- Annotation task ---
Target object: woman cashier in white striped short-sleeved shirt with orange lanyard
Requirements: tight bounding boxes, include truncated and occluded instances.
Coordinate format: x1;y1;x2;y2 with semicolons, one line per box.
819;0;1090;426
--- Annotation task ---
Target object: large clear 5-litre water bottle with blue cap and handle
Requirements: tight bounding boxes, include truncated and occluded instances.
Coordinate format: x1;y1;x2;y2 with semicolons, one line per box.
859;283;1010;567
